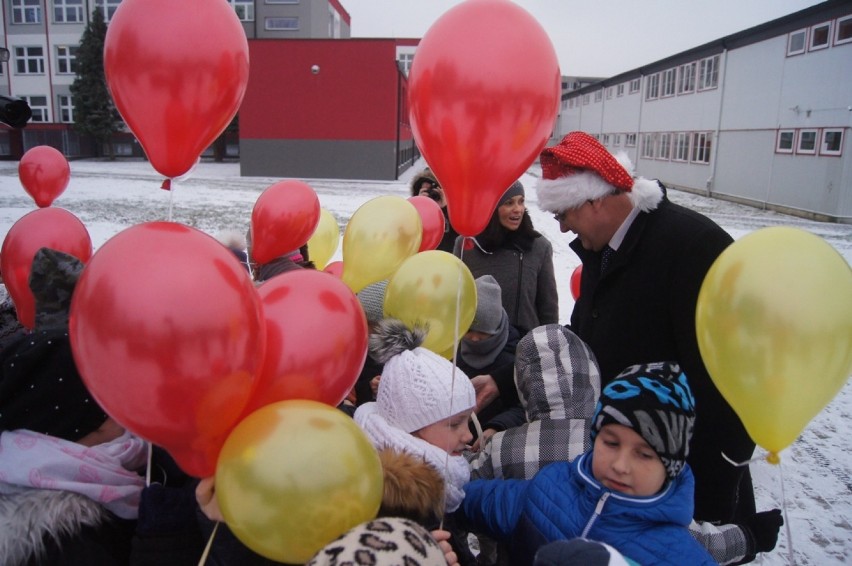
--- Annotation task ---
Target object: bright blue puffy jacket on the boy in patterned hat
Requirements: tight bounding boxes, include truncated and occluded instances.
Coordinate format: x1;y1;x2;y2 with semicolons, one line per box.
461;451;716;566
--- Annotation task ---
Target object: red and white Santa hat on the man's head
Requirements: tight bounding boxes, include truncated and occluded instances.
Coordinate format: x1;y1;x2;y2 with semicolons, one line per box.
536;132;663;212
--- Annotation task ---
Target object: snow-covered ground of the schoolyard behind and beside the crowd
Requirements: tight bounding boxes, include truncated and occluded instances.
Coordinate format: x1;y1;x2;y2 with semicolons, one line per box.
0;160;852;565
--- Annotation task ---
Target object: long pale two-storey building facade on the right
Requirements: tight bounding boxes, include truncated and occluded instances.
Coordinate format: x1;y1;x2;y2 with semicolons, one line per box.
558;0;852;223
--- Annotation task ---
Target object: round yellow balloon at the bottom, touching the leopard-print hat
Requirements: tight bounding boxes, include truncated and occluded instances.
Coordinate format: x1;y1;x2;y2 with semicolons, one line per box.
216;400;383;564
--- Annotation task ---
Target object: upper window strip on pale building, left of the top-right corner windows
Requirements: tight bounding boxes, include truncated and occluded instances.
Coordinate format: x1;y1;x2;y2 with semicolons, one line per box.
568;55;719;108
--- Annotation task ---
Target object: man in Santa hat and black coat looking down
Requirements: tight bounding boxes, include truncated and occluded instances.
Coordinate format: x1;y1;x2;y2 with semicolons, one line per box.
537;132;755;523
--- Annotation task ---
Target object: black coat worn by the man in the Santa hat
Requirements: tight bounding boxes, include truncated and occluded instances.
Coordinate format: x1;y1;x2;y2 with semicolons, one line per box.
571;194;755;523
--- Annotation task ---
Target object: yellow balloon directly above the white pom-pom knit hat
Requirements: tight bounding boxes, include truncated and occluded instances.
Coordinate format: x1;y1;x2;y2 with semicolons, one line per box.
384;250;476;357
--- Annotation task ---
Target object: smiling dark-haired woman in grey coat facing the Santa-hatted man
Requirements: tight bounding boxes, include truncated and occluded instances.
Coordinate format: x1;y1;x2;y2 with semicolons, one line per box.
455;181;559;336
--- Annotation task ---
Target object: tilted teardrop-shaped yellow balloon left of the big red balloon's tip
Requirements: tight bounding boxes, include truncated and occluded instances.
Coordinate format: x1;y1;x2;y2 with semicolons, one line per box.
342;196;423;293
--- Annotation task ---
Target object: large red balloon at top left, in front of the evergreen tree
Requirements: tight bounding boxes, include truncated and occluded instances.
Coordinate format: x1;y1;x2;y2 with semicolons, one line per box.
104;0;249;178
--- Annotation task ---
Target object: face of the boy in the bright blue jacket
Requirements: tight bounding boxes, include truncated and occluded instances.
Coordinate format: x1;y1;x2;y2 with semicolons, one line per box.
592;423;666;497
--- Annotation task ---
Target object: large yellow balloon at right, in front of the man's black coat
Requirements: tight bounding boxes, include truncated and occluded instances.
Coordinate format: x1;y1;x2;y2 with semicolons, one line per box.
695;227;852;463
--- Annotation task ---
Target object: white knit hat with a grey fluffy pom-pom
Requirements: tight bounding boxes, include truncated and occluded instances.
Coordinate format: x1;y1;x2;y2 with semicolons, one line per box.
370;318;476;433
